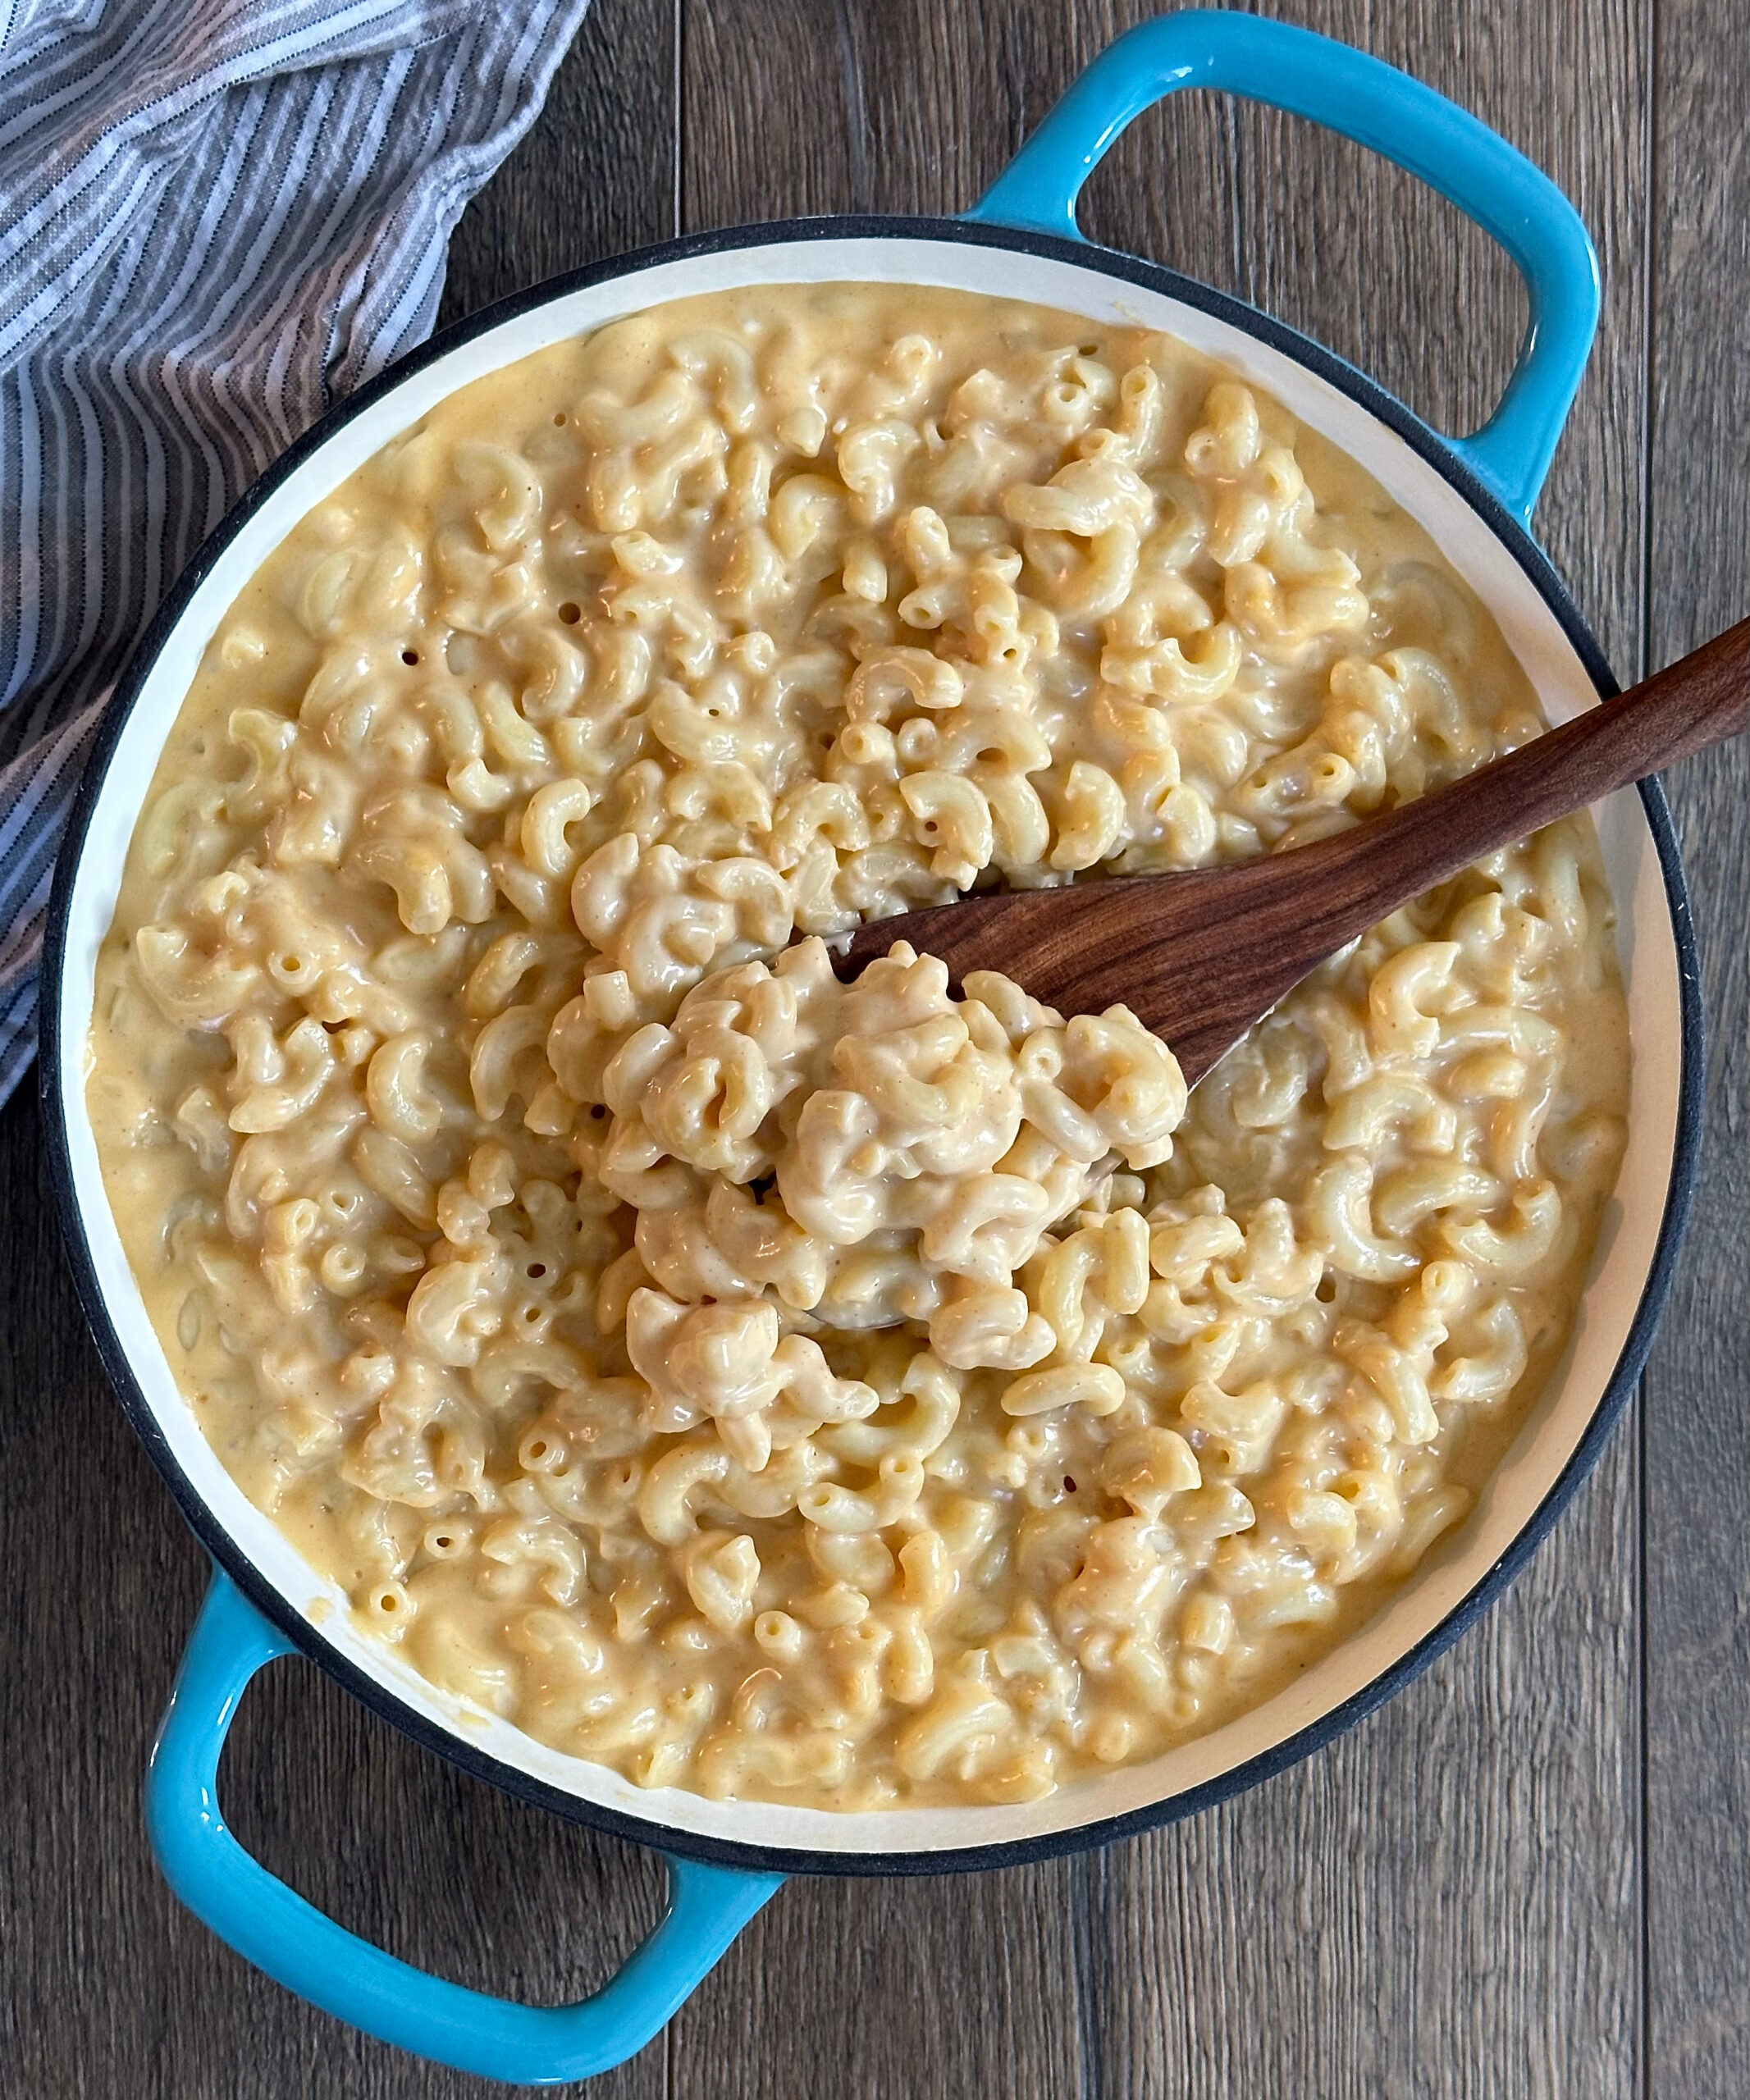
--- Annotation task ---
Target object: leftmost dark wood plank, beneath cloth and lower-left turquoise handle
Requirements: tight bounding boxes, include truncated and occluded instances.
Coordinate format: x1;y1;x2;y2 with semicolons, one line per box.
0;0;674;2100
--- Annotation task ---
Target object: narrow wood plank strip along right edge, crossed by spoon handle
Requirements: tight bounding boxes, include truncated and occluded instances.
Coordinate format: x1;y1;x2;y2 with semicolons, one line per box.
1645;0;1750;2100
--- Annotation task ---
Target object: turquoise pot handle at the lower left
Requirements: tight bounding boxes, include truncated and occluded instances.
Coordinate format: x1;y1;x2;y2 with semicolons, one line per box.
145;1571;784;2085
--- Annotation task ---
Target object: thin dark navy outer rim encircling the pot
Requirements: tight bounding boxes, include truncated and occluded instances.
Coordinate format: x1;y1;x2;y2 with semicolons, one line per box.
40;217;1704;1875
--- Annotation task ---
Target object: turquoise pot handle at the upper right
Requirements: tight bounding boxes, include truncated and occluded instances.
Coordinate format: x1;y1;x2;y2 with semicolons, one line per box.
966;8;1599;523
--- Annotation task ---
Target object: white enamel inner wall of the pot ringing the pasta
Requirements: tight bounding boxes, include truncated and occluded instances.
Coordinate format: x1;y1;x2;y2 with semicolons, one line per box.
50;237;1680;1854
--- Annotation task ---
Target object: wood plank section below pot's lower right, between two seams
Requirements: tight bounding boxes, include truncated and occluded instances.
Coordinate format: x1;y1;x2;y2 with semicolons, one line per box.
1093;1440;1638;2100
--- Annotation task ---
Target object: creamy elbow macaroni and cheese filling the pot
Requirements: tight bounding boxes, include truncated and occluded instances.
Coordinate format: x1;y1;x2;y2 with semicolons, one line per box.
90;285;1626;1808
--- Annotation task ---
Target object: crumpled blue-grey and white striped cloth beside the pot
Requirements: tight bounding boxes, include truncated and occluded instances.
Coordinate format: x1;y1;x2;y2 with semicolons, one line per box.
0;0;588;1100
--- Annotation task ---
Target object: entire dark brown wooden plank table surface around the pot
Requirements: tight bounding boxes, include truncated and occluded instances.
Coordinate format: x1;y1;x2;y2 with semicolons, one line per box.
0;0;1750;2100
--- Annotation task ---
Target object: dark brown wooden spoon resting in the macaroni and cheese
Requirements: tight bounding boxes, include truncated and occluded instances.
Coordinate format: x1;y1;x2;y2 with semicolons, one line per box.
834;619;1750;1086
